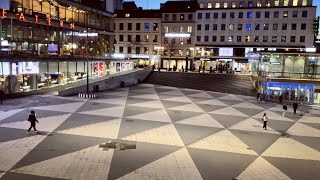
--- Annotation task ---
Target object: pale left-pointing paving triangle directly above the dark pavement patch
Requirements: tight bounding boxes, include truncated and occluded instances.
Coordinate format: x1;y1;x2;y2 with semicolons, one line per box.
58;119;121;139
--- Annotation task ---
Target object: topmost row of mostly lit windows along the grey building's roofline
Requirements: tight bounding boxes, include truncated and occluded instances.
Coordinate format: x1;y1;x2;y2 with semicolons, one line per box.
199;0;308;9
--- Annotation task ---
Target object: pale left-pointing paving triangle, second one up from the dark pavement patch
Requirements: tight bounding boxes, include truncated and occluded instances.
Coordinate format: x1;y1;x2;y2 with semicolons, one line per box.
79;106;125;117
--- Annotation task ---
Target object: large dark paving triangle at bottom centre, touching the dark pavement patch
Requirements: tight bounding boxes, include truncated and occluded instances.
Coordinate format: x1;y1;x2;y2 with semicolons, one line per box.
108;142;181;180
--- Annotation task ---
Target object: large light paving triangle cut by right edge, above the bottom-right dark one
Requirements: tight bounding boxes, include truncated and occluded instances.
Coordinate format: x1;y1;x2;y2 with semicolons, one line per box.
262;137;320;161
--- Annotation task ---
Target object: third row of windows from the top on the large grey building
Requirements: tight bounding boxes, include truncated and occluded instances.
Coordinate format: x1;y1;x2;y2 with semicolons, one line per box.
197;23;307;31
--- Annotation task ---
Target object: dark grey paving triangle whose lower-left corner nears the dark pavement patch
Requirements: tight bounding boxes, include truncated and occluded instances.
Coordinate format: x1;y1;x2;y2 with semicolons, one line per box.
118;118;169;138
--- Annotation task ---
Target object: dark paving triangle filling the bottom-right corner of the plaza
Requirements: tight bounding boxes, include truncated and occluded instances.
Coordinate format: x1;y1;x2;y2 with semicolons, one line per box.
263;156;320;180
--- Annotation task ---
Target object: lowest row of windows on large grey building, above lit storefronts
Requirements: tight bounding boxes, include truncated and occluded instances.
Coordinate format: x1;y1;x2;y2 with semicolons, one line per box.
197;36;306;43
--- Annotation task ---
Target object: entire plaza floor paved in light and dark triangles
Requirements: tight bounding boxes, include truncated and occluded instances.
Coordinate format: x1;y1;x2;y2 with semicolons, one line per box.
0;84;320;180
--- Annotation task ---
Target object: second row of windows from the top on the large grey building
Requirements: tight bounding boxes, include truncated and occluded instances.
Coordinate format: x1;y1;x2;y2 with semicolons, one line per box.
198;11;308;19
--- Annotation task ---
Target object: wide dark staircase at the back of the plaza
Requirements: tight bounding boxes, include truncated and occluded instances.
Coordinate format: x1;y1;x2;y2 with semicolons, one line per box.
143;71;256;96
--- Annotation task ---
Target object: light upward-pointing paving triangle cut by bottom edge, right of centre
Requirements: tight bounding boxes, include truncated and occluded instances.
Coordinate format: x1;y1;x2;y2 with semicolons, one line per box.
235;157;291;180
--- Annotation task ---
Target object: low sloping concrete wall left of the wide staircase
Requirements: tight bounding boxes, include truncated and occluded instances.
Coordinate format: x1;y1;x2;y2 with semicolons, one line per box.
59;68;151;96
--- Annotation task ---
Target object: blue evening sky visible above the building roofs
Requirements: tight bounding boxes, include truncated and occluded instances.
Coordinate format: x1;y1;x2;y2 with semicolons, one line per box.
126;0;320;16
